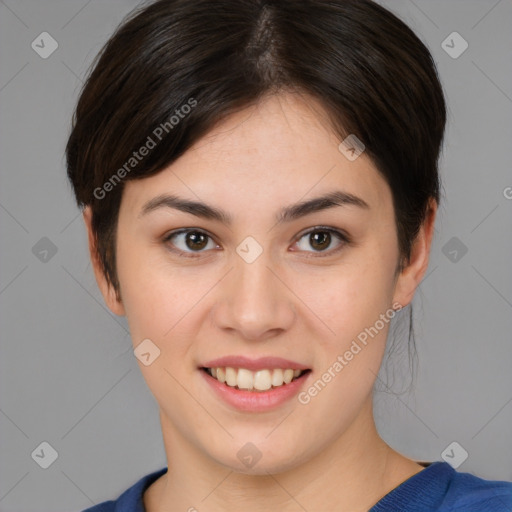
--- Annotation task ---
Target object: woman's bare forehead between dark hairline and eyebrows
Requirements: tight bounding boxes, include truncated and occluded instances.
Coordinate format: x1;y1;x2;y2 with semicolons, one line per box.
123;94;391;214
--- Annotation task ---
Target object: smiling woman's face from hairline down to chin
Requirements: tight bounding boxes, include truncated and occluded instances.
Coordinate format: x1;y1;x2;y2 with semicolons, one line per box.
88;95;428;473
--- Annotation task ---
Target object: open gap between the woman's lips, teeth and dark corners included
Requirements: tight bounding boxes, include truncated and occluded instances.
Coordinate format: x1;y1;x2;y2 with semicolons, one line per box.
201;366;311;393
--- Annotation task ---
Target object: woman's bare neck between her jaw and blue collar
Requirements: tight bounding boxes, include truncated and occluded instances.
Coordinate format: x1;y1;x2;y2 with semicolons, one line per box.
144;400;423;512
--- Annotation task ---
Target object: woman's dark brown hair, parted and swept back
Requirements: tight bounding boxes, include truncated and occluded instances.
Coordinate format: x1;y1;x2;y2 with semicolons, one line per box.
66;0;446;296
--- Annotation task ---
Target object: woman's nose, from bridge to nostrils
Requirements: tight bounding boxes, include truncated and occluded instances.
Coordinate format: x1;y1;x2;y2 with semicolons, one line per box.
213;252;295;341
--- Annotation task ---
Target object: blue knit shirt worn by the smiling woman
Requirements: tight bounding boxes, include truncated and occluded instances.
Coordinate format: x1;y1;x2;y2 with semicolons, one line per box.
83;461;512;512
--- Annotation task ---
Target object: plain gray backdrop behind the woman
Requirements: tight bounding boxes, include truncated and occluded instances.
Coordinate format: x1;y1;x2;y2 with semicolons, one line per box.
0;0;512;512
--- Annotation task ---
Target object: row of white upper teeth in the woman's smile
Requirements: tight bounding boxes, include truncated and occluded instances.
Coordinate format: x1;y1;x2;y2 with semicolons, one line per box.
207;366;302;391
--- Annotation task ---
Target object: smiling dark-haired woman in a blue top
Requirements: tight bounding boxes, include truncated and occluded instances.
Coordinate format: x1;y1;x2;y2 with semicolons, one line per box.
67;0;512;512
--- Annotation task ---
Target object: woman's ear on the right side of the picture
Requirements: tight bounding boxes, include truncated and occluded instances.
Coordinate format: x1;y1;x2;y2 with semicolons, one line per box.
393;199;437;307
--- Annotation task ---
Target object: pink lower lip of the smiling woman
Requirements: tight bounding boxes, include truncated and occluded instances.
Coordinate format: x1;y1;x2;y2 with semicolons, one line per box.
199;370;311;412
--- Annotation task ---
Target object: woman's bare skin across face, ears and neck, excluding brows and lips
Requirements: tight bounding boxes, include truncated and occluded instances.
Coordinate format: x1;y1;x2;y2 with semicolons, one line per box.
84;93;437;512
